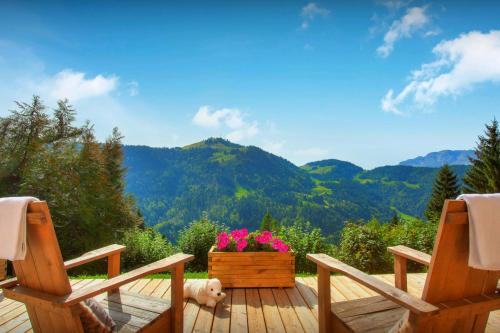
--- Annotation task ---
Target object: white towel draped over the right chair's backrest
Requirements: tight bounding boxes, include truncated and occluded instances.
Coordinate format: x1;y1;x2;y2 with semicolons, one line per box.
457;193;500;271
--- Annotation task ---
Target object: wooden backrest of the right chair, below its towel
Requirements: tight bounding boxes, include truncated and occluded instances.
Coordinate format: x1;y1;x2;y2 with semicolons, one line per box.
422;200;500;332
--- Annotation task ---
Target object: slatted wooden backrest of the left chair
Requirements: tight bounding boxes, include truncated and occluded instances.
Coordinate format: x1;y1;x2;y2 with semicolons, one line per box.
13;201;83;332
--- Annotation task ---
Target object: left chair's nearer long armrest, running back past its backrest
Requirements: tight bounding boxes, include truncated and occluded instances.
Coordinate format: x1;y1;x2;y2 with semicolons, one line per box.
3;253;194;307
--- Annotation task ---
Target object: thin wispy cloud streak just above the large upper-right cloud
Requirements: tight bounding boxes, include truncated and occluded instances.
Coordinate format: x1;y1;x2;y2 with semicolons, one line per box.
377;6;430;58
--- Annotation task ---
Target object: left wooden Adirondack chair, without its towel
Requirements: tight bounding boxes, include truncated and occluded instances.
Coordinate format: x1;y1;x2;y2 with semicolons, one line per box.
0;201;193;333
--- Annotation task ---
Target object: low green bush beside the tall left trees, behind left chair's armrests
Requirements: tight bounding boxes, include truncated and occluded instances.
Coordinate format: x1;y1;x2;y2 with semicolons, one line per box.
122;228;174;270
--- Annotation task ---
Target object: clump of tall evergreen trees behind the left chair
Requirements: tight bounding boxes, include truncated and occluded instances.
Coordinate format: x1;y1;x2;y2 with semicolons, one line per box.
0;96;142;257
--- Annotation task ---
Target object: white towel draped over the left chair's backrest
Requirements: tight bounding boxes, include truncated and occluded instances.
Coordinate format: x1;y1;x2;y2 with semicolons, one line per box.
0;197;38;260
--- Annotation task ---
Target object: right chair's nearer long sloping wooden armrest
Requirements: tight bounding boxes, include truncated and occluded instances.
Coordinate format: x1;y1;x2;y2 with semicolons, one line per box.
307;254;439;316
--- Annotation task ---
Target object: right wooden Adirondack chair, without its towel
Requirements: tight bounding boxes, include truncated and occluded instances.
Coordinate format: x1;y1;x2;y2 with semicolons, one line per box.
307;200;500;333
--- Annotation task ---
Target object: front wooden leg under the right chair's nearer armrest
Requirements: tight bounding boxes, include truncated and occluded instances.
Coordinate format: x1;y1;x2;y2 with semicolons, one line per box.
318;265;333;333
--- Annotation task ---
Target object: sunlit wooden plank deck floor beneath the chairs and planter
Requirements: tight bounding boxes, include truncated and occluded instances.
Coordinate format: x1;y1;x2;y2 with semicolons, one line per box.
0;273;500;333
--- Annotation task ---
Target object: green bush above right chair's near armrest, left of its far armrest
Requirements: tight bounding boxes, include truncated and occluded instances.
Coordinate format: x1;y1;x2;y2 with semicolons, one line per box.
336;220;390;273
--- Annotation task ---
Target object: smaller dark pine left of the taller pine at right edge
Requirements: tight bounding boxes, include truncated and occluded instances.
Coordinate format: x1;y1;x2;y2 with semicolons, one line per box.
425;165;460;221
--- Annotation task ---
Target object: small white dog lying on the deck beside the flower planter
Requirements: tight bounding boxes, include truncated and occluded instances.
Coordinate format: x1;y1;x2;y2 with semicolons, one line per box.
184;279;226;308
